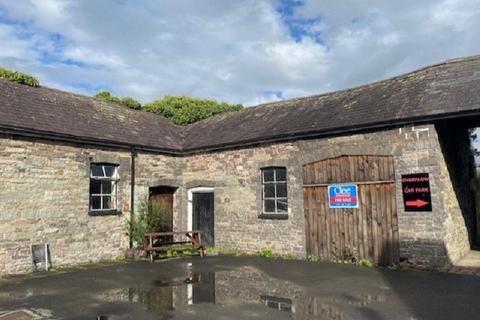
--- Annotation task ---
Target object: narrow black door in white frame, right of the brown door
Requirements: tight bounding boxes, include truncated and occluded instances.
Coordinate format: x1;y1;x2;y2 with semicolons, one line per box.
192;192;215;247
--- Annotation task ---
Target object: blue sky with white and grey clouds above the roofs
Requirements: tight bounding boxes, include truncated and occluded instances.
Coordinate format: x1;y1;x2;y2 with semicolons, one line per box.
0;0;480;105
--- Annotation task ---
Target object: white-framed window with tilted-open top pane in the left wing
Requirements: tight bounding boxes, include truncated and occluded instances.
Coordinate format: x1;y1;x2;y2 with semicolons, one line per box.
90;163;119;211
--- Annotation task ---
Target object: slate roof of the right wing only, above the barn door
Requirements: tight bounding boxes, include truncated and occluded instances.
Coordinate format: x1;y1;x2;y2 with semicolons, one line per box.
183;56;480;151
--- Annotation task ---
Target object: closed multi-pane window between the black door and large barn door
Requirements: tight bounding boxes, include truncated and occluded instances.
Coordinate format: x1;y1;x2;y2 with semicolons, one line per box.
262;167;288;214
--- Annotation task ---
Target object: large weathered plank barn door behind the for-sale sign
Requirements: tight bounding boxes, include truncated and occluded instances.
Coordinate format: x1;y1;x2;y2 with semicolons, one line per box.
303;156;399;265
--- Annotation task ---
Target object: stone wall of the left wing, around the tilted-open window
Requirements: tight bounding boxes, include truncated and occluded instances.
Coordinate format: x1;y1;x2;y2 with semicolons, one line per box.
0;136;181;273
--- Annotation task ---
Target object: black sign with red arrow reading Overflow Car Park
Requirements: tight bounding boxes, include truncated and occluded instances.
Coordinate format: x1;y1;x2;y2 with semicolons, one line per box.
402;173;432;211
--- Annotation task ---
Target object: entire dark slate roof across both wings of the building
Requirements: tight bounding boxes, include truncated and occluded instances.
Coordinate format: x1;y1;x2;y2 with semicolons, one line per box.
0;56;480;153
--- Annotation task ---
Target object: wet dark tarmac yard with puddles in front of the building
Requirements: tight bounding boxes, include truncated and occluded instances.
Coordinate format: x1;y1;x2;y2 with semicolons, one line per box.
0;257;480;320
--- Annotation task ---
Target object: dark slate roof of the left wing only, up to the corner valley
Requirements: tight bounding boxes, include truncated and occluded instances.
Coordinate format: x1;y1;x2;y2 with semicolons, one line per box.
0;80;183;152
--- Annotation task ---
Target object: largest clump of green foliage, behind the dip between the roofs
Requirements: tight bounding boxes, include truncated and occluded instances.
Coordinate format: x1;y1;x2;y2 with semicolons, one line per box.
144;96;243;125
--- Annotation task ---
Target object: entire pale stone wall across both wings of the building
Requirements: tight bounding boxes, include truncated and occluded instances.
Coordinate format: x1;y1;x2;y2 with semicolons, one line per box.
0;121;469;273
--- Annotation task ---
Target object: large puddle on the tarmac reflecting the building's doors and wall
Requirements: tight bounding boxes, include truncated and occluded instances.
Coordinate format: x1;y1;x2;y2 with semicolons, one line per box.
99;267;390;320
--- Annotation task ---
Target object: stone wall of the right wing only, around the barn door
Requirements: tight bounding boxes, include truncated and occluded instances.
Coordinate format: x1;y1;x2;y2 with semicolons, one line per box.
178;125;468;267
